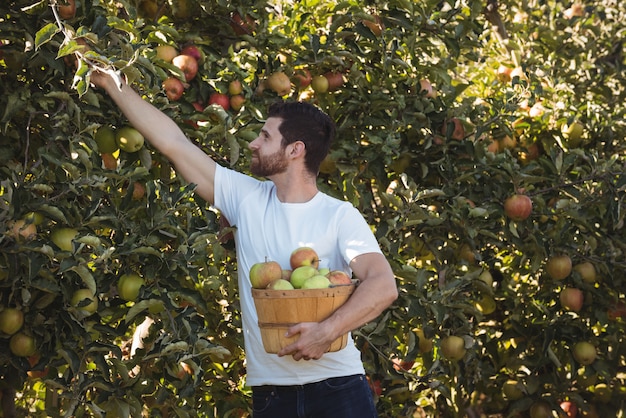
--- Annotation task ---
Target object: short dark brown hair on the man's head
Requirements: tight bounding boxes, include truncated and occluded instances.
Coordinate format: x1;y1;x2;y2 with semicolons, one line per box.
268;101;335;175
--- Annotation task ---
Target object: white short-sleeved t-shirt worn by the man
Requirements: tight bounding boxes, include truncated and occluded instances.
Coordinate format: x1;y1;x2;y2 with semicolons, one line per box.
215;165;381;386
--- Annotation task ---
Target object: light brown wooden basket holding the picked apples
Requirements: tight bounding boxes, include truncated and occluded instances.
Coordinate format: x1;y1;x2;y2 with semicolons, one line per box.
252;284;355;354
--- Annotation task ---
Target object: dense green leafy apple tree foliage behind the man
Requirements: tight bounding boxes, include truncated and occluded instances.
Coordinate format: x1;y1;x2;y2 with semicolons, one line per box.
0;0;626;417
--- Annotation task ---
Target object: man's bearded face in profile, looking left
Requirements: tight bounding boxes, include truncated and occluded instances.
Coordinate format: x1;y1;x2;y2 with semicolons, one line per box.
248;118;288;178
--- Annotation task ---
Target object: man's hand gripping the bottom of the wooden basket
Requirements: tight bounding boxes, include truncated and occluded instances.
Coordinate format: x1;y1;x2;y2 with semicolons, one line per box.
278;322;333;361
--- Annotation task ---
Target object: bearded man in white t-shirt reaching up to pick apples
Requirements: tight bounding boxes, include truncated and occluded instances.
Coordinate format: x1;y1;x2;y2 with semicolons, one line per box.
91;73;398;418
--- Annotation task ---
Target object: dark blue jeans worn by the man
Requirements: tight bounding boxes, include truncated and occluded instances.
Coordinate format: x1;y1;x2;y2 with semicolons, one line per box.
252;375;378;418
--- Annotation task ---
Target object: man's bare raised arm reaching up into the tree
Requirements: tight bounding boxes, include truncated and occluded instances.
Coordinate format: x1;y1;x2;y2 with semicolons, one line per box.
91;71;216;204
